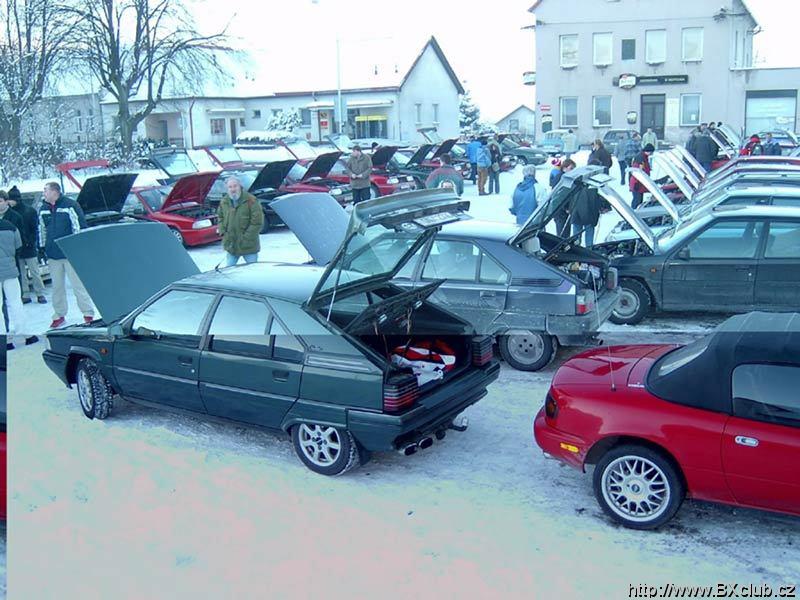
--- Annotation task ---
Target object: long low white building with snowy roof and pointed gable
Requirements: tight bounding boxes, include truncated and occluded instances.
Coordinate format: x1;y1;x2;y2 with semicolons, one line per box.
97;37;464;147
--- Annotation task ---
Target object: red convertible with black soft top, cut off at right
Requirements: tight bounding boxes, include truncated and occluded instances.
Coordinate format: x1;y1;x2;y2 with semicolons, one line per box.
534;312;800;529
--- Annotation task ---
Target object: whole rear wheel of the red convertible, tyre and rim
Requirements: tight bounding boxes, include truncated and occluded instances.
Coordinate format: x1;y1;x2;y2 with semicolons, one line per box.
592;445;686;529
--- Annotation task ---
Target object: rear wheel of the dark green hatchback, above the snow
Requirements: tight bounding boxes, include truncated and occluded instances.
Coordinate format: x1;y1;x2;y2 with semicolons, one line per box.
292;423;360;476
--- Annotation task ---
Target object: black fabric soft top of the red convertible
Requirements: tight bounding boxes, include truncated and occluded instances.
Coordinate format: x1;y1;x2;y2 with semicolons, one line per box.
647;312;800;414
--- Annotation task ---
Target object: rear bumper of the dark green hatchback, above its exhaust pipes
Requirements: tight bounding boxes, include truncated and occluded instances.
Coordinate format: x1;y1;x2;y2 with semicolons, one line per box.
347;360;500;452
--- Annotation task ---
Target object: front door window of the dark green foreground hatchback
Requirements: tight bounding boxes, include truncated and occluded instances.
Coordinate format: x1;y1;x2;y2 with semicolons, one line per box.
131;290;214;341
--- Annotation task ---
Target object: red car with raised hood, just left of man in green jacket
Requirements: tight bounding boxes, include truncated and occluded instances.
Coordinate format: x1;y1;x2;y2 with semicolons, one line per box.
122;173;222;246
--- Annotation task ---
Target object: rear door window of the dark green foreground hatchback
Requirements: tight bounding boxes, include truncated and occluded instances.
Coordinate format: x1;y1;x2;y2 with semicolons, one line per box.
208;296;270;358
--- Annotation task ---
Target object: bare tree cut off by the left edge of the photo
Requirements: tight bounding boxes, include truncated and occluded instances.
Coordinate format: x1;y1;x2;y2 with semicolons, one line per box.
0;0;75;148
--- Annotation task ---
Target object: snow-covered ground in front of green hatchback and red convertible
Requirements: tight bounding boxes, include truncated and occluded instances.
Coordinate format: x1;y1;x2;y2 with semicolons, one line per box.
9;340;800;598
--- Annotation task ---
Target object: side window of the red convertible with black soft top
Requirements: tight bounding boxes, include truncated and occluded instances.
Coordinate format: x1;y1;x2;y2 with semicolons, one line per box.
732;365;800;428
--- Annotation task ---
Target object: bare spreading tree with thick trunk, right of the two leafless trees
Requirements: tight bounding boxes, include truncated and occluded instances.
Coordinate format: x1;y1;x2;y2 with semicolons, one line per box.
75;0;228;150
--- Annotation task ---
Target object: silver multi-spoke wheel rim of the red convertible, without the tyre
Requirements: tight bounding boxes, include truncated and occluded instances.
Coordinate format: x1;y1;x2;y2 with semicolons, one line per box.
602;456;670;522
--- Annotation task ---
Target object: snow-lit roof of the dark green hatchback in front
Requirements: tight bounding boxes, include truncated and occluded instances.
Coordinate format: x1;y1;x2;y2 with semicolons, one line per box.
177;262;325;304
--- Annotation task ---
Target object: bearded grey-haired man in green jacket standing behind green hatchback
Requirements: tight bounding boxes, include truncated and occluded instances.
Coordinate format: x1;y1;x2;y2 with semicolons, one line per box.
217;177;264;267
